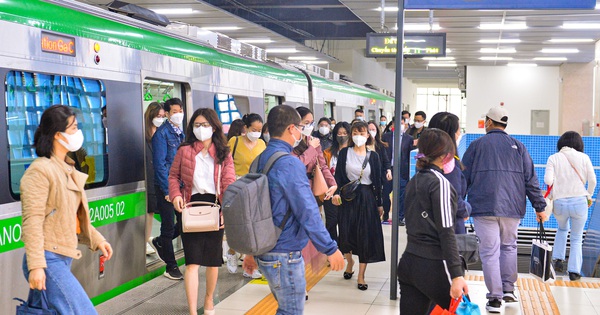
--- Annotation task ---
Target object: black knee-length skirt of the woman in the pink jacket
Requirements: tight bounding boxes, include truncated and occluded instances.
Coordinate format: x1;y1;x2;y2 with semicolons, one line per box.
179;194;223;267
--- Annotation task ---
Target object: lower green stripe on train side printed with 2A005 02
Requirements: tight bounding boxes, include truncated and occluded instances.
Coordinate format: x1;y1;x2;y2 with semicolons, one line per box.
0;192;146;253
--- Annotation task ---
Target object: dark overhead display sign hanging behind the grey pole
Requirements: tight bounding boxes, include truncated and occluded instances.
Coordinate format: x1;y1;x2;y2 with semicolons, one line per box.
367;33;446;58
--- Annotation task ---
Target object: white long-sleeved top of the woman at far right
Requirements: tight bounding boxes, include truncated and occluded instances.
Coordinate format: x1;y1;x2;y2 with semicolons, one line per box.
544;147;596;200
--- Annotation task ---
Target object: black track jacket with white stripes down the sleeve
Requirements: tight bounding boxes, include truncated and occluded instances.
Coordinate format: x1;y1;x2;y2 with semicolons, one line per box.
404;166;464;279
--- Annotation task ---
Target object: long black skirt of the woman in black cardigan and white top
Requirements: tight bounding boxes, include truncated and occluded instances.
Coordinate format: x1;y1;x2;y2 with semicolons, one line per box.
338;185;385;263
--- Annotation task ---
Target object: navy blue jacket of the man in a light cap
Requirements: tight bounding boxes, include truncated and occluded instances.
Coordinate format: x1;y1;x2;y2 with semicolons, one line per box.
462;129;546;218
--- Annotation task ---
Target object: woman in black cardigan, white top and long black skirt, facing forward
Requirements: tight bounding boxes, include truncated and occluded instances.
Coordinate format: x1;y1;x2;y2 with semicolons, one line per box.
333;122;385;291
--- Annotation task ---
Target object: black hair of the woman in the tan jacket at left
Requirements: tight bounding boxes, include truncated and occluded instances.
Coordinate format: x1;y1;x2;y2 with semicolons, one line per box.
33;105;75;158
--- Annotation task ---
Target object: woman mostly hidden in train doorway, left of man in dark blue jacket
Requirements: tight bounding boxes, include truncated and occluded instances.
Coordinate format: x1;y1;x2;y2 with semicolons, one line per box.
144;102;165;255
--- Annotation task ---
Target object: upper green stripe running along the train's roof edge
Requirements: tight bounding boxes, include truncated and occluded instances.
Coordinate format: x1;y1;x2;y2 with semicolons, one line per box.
0;0;394;102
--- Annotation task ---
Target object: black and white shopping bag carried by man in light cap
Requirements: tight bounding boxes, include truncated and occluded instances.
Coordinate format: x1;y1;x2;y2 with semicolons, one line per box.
529;222;556;282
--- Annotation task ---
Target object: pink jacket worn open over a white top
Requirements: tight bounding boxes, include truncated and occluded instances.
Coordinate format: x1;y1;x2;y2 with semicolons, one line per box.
169;141;235;203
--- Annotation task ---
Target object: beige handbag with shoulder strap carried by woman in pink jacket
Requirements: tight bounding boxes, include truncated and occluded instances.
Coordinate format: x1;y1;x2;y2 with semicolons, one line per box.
181;165;222;233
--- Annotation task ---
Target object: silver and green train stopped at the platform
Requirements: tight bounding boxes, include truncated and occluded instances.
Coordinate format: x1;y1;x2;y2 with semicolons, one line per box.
0;0;394;314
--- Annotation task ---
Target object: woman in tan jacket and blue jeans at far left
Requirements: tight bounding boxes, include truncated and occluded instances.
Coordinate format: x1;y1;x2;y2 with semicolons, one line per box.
21;105;113;314
